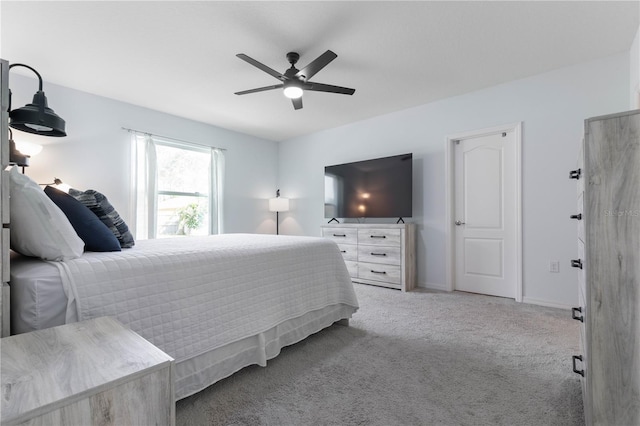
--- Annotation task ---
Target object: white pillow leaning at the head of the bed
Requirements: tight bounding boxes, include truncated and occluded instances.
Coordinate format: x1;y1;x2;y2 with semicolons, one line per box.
9;166;84;260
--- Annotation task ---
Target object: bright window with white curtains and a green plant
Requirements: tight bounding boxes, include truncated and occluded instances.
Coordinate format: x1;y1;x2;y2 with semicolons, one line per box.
132;133;224;239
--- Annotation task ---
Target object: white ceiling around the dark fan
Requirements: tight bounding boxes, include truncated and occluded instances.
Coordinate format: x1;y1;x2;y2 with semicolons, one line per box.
0;0;640;141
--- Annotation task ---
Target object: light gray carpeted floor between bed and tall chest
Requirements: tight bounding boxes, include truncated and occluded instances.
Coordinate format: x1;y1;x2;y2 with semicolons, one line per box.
176;284;584;426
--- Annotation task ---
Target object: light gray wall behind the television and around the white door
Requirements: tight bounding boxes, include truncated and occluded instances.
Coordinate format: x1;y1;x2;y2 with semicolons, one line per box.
278;53;629;306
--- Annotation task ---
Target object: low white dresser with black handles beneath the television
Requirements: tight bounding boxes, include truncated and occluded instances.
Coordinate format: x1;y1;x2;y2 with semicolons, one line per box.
322;223;416;291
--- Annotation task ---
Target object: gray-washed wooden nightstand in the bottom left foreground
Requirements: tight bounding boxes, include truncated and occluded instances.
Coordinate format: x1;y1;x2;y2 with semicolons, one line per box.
0;317;175;426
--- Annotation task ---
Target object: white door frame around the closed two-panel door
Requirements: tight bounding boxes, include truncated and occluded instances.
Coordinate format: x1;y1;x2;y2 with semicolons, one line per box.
445;121;522;302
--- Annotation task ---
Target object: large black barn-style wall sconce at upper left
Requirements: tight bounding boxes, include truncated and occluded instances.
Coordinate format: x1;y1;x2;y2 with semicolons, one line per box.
9;64;67;137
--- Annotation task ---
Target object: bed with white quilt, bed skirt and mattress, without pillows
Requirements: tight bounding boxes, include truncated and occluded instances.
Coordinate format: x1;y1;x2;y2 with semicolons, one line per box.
10;234;358;399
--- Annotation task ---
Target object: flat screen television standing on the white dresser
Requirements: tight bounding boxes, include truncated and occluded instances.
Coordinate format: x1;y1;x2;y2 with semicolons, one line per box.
324;154;413;218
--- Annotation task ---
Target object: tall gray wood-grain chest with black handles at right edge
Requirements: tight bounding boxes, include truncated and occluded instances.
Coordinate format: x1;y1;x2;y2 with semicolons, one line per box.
570;110;640;426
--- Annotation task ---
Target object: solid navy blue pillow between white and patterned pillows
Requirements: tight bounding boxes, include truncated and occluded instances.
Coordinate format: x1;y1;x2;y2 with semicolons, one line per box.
44;186;121;251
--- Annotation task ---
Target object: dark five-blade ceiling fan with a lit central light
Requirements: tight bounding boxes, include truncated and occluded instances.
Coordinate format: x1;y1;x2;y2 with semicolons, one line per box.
236;50;356;109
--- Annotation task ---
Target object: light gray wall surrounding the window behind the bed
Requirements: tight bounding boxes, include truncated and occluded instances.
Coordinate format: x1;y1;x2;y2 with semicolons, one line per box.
10;72;278;233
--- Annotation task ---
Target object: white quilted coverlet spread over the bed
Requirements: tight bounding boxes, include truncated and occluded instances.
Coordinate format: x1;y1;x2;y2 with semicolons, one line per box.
57;234;358;362
